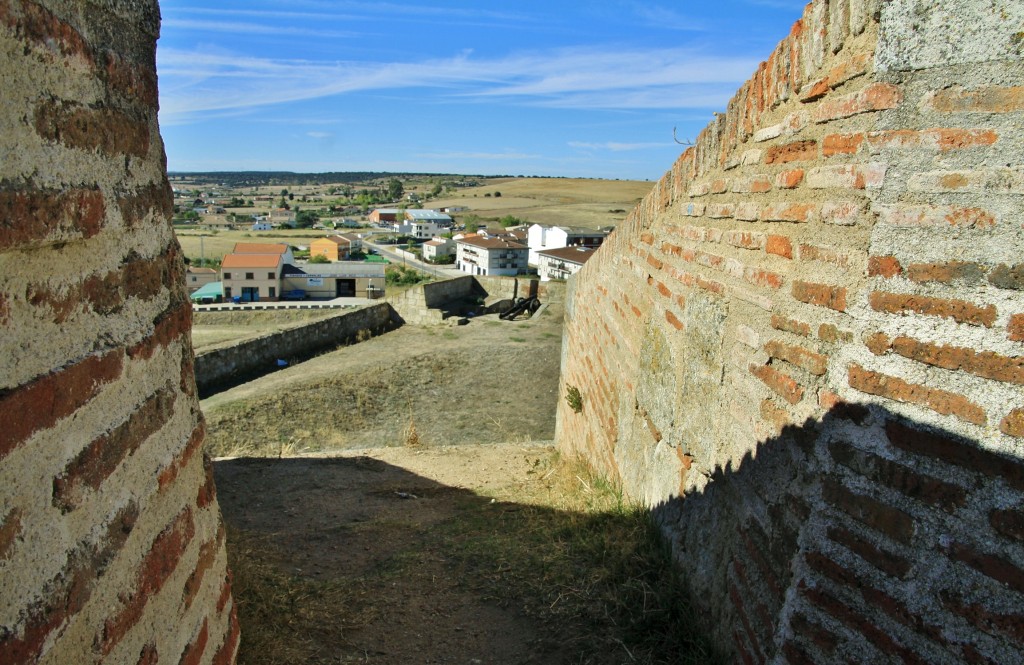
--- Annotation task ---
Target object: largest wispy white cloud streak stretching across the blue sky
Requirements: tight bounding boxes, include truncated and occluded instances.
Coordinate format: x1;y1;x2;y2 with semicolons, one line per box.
158;48;758;123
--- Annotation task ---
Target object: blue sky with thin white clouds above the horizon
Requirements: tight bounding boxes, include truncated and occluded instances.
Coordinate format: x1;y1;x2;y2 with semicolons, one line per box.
157;0;805;179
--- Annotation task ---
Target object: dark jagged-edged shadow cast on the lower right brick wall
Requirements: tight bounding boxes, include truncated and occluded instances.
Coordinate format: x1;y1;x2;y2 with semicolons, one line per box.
654;405;1024;663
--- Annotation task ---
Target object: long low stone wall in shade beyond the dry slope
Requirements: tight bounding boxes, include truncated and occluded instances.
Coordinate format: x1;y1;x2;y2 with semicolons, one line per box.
196;302;399;394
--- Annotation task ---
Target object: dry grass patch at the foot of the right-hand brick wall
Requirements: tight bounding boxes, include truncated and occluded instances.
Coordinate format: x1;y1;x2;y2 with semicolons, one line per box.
449;455;718;665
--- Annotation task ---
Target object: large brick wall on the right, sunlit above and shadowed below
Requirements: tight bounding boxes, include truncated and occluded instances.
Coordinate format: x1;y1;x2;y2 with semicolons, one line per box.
556;0;1024;663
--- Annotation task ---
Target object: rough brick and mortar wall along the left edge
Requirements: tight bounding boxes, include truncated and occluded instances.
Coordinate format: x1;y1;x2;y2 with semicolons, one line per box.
0;0;239;664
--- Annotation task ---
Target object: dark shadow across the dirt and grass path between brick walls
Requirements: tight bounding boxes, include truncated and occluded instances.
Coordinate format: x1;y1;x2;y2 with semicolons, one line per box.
215;457;708;665
